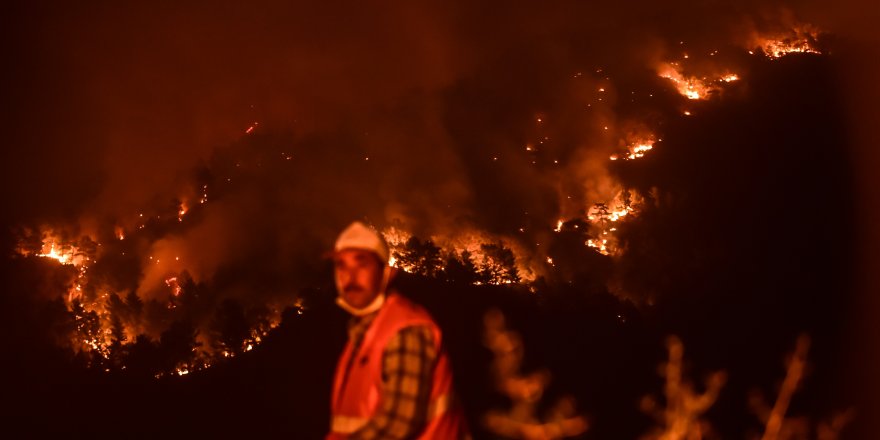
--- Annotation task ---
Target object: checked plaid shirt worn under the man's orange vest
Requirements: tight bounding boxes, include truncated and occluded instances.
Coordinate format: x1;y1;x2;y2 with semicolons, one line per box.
346;312;437;440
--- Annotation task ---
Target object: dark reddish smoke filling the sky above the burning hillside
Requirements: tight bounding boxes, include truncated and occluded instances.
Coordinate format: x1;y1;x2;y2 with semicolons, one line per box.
4;1;832;306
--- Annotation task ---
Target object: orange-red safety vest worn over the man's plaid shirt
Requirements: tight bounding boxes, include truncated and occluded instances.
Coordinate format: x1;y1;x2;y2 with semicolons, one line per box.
327;293;467;440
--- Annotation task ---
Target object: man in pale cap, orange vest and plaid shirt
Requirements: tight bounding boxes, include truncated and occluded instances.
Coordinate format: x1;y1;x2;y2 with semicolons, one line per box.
327;222;466;440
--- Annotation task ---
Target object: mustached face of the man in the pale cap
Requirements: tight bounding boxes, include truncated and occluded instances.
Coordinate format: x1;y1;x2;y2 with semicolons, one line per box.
333;249;382;309
